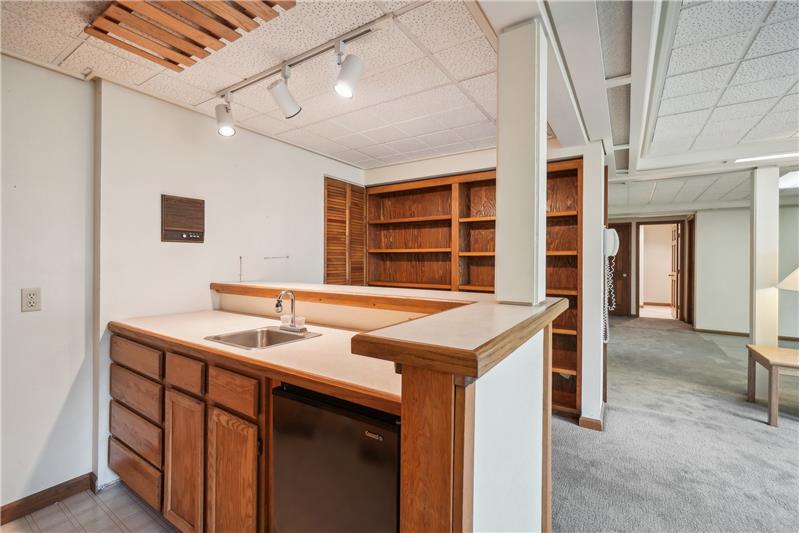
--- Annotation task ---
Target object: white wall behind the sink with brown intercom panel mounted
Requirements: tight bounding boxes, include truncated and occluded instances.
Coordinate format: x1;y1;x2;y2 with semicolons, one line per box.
96;82;363;484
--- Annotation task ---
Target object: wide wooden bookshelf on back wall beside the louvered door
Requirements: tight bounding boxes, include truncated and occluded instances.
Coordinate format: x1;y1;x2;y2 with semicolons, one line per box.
367;171;496;292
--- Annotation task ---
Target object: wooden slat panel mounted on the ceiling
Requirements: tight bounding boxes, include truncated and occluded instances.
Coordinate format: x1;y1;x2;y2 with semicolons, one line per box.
84;0;295;72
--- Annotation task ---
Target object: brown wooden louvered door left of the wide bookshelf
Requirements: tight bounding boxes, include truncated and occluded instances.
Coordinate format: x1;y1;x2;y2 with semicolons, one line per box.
325;178;366;285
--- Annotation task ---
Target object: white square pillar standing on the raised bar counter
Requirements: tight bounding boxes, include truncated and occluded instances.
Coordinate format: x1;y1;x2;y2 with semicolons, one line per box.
495;21;547;304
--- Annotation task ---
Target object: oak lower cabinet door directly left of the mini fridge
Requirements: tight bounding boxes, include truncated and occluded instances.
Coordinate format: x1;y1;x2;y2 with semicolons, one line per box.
206;407;258;533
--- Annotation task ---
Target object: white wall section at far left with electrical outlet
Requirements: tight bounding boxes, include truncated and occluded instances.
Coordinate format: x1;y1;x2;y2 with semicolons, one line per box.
0;56;93;504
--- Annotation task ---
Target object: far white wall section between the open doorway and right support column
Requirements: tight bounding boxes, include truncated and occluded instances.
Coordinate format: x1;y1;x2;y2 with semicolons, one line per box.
695;209;750;333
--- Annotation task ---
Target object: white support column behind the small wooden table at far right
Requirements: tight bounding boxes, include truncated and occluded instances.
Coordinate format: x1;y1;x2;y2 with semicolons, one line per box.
750;167;780;346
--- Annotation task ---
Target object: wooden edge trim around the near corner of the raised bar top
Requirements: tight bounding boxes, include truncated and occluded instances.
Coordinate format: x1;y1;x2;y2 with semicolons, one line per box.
351;298;569;378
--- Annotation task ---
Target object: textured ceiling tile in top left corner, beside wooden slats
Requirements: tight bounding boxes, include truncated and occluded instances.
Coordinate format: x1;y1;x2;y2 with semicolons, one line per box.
2;0;108;38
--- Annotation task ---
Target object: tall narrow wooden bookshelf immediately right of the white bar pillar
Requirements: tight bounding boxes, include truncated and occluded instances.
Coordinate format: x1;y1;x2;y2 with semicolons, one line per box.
546;159;583;416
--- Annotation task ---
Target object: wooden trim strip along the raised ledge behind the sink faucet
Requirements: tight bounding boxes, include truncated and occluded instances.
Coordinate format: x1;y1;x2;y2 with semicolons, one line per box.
211;283;473;314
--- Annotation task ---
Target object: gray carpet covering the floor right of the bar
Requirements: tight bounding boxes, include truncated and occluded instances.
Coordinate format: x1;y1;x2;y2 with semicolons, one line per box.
553;319;798;532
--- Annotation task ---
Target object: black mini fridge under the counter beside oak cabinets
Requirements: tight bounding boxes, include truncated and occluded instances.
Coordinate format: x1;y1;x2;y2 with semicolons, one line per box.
272;385;400;533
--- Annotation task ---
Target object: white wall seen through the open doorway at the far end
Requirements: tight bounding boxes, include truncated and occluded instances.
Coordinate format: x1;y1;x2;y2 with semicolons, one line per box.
640;224;675;304
